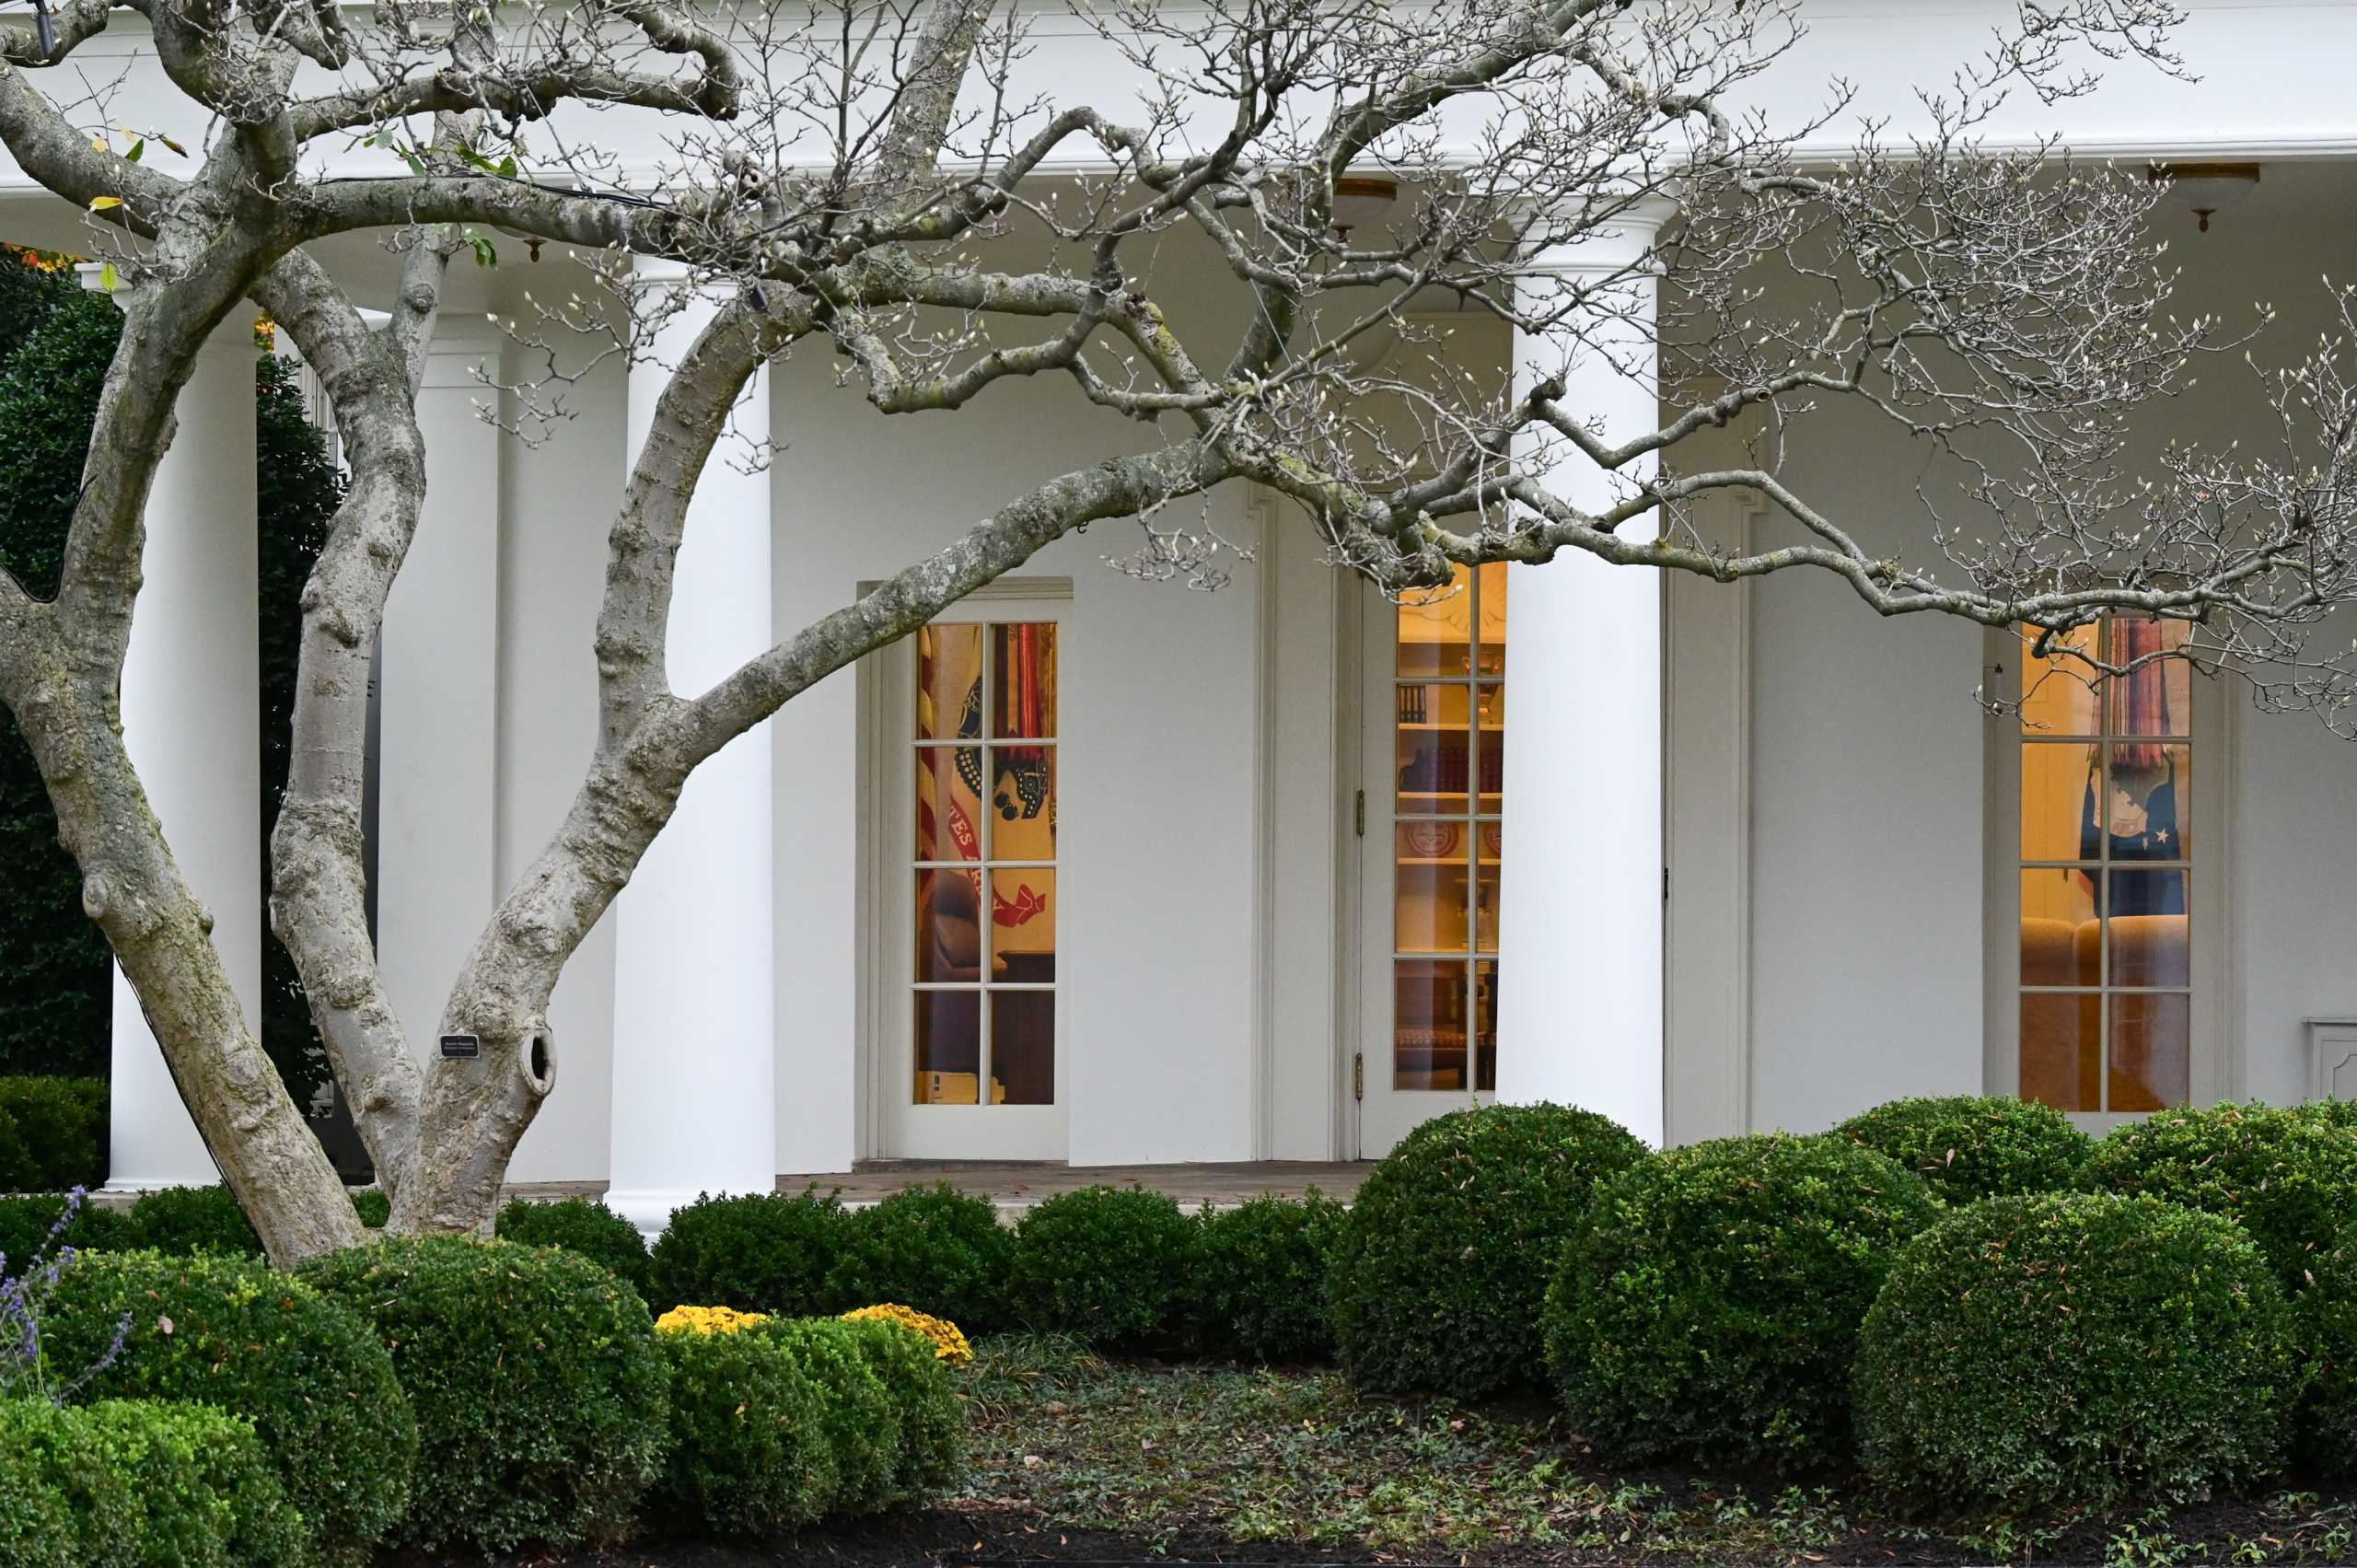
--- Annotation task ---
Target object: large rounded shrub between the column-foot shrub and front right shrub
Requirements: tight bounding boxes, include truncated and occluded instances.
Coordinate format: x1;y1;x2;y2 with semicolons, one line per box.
1546;1134;1942;1469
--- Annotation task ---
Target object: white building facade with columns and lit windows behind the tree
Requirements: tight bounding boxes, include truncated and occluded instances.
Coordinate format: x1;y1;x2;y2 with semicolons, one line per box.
32;0;2357;1224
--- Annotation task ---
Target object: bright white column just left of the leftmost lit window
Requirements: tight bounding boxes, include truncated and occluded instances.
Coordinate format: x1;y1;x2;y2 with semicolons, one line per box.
606;261;777;1233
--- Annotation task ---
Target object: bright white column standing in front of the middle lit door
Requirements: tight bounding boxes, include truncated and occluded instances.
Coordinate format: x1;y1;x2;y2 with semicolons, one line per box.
1497;210;1666;1144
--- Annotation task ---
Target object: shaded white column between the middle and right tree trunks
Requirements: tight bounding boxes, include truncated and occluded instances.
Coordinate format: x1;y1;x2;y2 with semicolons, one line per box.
377;316;500;1074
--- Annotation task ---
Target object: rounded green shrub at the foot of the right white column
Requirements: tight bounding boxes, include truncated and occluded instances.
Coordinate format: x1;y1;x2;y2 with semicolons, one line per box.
1331;1106;1645;1399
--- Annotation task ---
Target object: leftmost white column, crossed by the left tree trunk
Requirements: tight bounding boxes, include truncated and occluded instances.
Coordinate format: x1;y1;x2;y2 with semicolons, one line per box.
106;289;261;1191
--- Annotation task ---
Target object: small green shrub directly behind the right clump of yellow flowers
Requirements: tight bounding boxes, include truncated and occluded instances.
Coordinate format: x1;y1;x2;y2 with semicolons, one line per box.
825;1181;1016;1334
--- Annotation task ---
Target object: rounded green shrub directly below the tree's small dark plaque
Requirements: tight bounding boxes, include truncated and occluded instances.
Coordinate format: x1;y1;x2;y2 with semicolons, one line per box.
302;1236;669;1551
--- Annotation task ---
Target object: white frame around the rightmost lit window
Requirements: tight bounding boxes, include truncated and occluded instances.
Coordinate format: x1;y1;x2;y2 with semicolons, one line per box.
1982;630;2244;1134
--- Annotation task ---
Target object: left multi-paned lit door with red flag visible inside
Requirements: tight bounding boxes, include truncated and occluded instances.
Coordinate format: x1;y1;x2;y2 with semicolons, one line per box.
877;598;1065;1160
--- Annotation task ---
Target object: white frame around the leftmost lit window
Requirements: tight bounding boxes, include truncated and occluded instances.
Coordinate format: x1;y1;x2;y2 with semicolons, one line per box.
858;577;1085;1160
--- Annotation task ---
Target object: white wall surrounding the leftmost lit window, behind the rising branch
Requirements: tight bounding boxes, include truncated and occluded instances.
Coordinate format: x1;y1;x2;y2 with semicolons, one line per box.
771;318;1259;1172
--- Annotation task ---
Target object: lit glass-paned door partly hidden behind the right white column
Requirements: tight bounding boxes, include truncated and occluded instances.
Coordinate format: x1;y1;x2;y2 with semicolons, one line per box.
1353;566;1506;1157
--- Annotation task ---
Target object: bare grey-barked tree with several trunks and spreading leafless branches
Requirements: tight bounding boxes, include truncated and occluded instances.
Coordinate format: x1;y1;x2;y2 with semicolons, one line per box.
0;0;2357;1261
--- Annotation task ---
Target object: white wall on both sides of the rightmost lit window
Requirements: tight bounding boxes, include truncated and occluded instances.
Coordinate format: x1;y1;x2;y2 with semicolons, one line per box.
1749;163;2357;1130
